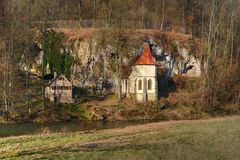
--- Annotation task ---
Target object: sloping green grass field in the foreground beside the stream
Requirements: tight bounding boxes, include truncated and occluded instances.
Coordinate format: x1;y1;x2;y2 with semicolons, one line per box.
0;116;240;160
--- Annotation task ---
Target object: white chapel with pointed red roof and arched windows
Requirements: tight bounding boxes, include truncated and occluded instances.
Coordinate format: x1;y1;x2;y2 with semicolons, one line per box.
121;44;157;102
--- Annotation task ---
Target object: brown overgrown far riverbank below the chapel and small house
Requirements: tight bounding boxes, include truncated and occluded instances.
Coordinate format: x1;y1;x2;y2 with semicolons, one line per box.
0;91;240;124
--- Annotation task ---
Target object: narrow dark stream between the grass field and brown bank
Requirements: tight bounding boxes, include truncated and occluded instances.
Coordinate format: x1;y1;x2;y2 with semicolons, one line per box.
0;120;158;137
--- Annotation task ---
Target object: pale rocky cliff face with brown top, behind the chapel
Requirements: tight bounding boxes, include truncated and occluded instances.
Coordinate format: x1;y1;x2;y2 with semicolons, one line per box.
31;29;201;86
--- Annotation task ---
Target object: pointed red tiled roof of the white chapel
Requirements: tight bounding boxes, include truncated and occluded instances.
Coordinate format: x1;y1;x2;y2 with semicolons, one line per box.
135;44;154;65
